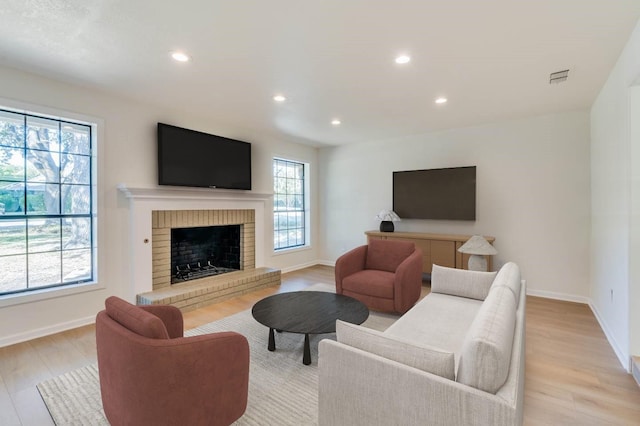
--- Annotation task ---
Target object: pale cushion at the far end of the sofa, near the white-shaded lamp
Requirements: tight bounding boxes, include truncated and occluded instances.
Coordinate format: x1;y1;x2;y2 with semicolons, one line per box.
431;264;497;300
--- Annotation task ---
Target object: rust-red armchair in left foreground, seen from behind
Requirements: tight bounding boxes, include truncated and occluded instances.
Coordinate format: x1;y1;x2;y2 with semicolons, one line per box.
96;297;249;426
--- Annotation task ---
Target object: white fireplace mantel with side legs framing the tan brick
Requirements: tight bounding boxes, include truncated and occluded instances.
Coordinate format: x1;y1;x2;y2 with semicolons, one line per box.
118;184;273;302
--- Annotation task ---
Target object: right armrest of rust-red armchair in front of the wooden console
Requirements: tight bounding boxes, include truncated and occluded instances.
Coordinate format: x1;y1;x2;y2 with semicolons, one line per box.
393;248;422;314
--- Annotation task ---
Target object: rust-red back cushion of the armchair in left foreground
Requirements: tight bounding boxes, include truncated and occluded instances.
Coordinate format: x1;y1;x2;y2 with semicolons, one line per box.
104;296;169;339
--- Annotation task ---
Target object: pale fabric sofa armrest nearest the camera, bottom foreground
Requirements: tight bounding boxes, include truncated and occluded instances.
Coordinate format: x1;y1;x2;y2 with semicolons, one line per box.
318;339;523;426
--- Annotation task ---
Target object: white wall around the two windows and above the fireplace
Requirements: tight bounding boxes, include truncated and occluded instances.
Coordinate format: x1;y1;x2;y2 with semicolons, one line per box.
0;68;318;346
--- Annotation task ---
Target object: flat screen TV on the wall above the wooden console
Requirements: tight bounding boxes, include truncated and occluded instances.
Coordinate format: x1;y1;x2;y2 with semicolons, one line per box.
393;166;476;220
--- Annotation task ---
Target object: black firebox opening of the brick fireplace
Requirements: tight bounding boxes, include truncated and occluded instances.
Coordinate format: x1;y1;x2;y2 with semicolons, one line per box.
171;225;242;284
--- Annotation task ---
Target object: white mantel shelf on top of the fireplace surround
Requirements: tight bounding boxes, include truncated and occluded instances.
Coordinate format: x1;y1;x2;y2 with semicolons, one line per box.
118;183;273;201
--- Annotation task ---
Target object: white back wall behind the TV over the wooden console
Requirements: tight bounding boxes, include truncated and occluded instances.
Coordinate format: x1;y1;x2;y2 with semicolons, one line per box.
320;111;590;302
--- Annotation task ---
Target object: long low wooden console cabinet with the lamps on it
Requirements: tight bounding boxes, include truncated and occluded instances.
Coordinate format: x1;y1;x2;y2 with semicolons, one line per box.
365;231;495;274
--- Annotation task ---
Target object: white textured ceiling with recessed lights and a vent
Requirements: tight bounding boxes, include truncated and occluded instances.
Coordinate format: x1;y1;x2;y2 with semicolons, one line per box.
0;0;640;146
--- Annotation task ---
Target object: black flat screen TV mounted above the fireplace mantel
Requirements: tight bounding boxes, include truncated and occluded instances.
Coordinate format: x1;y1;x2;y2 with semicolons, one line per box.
158;123;251;190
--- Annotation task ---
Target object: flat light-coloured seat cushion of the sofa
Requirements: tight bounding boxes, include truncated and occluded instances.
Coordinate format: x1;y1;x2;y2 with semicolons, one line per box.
384;293;482;369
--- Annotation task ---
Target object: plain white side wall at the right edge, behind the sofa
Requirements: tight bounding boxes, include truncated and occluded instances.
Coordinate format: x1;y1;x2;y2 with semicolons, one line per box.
591;18;640;368
